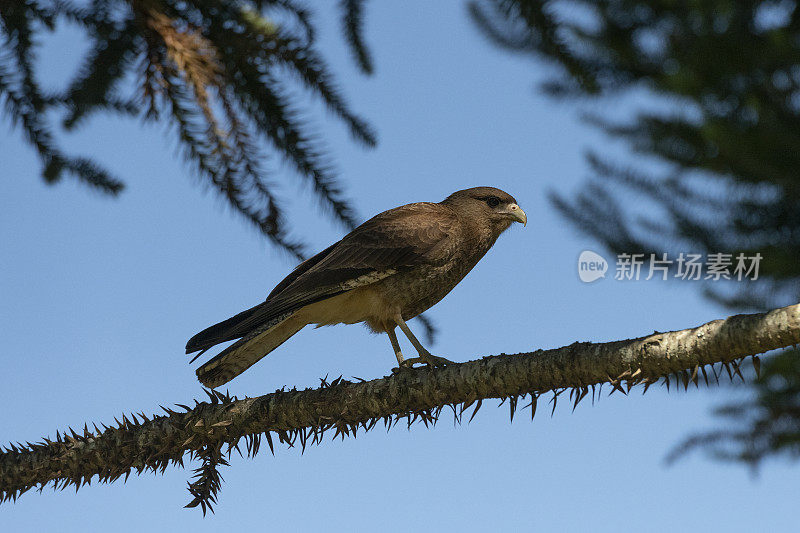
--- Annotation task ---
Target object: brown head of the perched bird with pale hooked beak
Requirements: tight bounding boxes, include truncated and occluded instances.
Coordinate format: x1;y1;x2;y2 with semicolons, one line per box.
442;187;528;234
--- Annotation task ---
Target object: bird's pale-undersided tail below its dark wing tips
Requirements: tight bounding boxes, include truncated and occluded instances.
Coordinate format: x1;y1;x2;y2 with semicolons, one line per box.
196;312;306;389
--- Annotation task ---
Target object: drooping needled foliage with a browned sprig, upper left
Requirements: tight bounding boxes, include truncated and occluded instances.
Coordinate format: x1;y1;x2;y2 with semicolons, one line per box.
0;0;376;257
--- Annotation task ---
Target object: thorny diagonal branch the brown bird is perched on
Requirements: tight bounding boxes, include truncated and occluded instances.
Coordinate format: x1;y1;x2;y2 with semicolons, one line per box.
0;304;800;513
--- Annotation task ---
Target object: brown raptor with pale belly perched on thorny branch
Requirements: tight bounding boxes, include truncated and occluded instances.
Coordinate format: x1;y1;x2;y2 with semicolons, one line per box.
186;187;528;388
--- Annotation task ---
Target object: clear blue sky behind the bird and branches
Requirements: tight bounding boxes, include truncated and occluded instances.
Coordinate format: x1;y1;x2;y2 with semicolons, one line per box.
0;1;800;531
